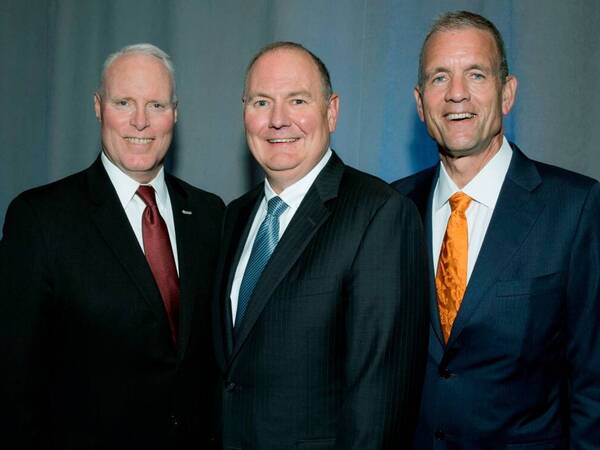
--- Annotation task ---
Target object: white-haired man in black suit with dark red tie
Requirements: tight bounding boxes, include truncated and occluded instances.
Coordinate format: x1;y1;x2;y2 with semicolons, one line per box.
0;44;223;450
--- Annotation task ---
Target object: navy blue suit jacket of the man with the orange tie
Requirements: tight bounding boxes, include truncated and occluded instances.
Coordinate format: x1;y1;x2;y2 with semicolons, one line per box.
393;145;600;450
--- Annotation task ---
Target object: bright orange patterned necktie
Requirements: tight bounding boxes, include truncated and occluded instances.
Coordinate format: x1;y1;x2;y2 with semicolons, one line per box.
435;192;471;342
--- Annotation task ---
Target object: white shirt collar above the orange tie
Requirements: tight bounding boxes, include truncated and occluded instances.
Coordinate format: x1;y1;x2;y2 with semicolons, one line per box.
434;136;512;210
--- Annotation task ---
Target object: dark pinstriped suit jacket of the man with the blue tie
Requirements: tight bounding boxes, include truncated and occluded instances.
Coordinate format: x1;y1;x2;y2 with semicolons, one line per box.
214;154;427;450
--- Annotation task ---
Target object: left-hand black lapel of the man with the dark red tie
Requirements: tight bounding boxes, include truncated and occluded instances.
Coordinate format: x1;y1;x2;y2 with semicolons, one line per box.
87;158;169;339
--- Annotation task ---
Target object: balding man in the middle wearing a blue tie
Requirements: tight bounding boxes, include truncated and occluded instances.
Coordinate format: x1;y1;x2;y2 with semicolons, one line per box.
214;42;427;450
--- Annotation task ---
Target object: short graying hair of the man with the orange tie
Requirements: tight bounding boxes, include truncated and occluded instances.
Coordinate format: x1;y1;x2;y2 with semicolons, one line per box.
418;11;508;91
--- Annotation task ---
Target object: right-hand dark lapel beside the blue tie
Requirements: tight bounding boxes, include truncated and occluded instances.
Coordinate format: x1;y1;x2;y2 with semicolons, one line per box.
231;153;344;360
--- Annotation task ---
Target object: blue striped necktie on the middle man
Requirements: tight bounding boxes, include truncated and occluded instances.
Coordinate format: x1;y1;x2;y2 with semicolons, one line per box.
235;197;287;327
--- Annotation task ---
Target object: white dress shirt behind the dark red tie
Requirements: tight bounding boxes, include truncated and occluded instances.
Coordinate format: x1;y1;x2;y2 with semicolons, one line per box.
100;152;179;274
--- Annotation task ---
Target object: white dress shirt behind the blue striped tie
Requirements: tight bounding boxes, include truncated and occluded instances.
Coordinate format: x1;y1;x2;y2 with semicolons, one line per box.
230;149;331;323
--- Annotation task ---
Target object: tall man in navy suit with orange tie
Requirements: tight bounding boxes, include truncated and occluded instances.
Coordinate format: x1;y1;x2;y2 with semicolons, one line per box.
394;11;600;450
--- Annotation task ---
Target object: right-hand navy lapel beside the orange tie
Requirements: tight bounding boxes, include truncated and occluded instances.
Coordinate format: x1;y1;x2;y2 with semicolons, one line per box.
448;145;545;346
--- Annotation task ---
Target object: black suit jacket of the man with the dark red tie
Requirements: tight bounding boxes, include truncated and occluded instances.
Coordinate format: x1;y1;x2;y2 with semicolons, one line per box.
0;159;223;450
